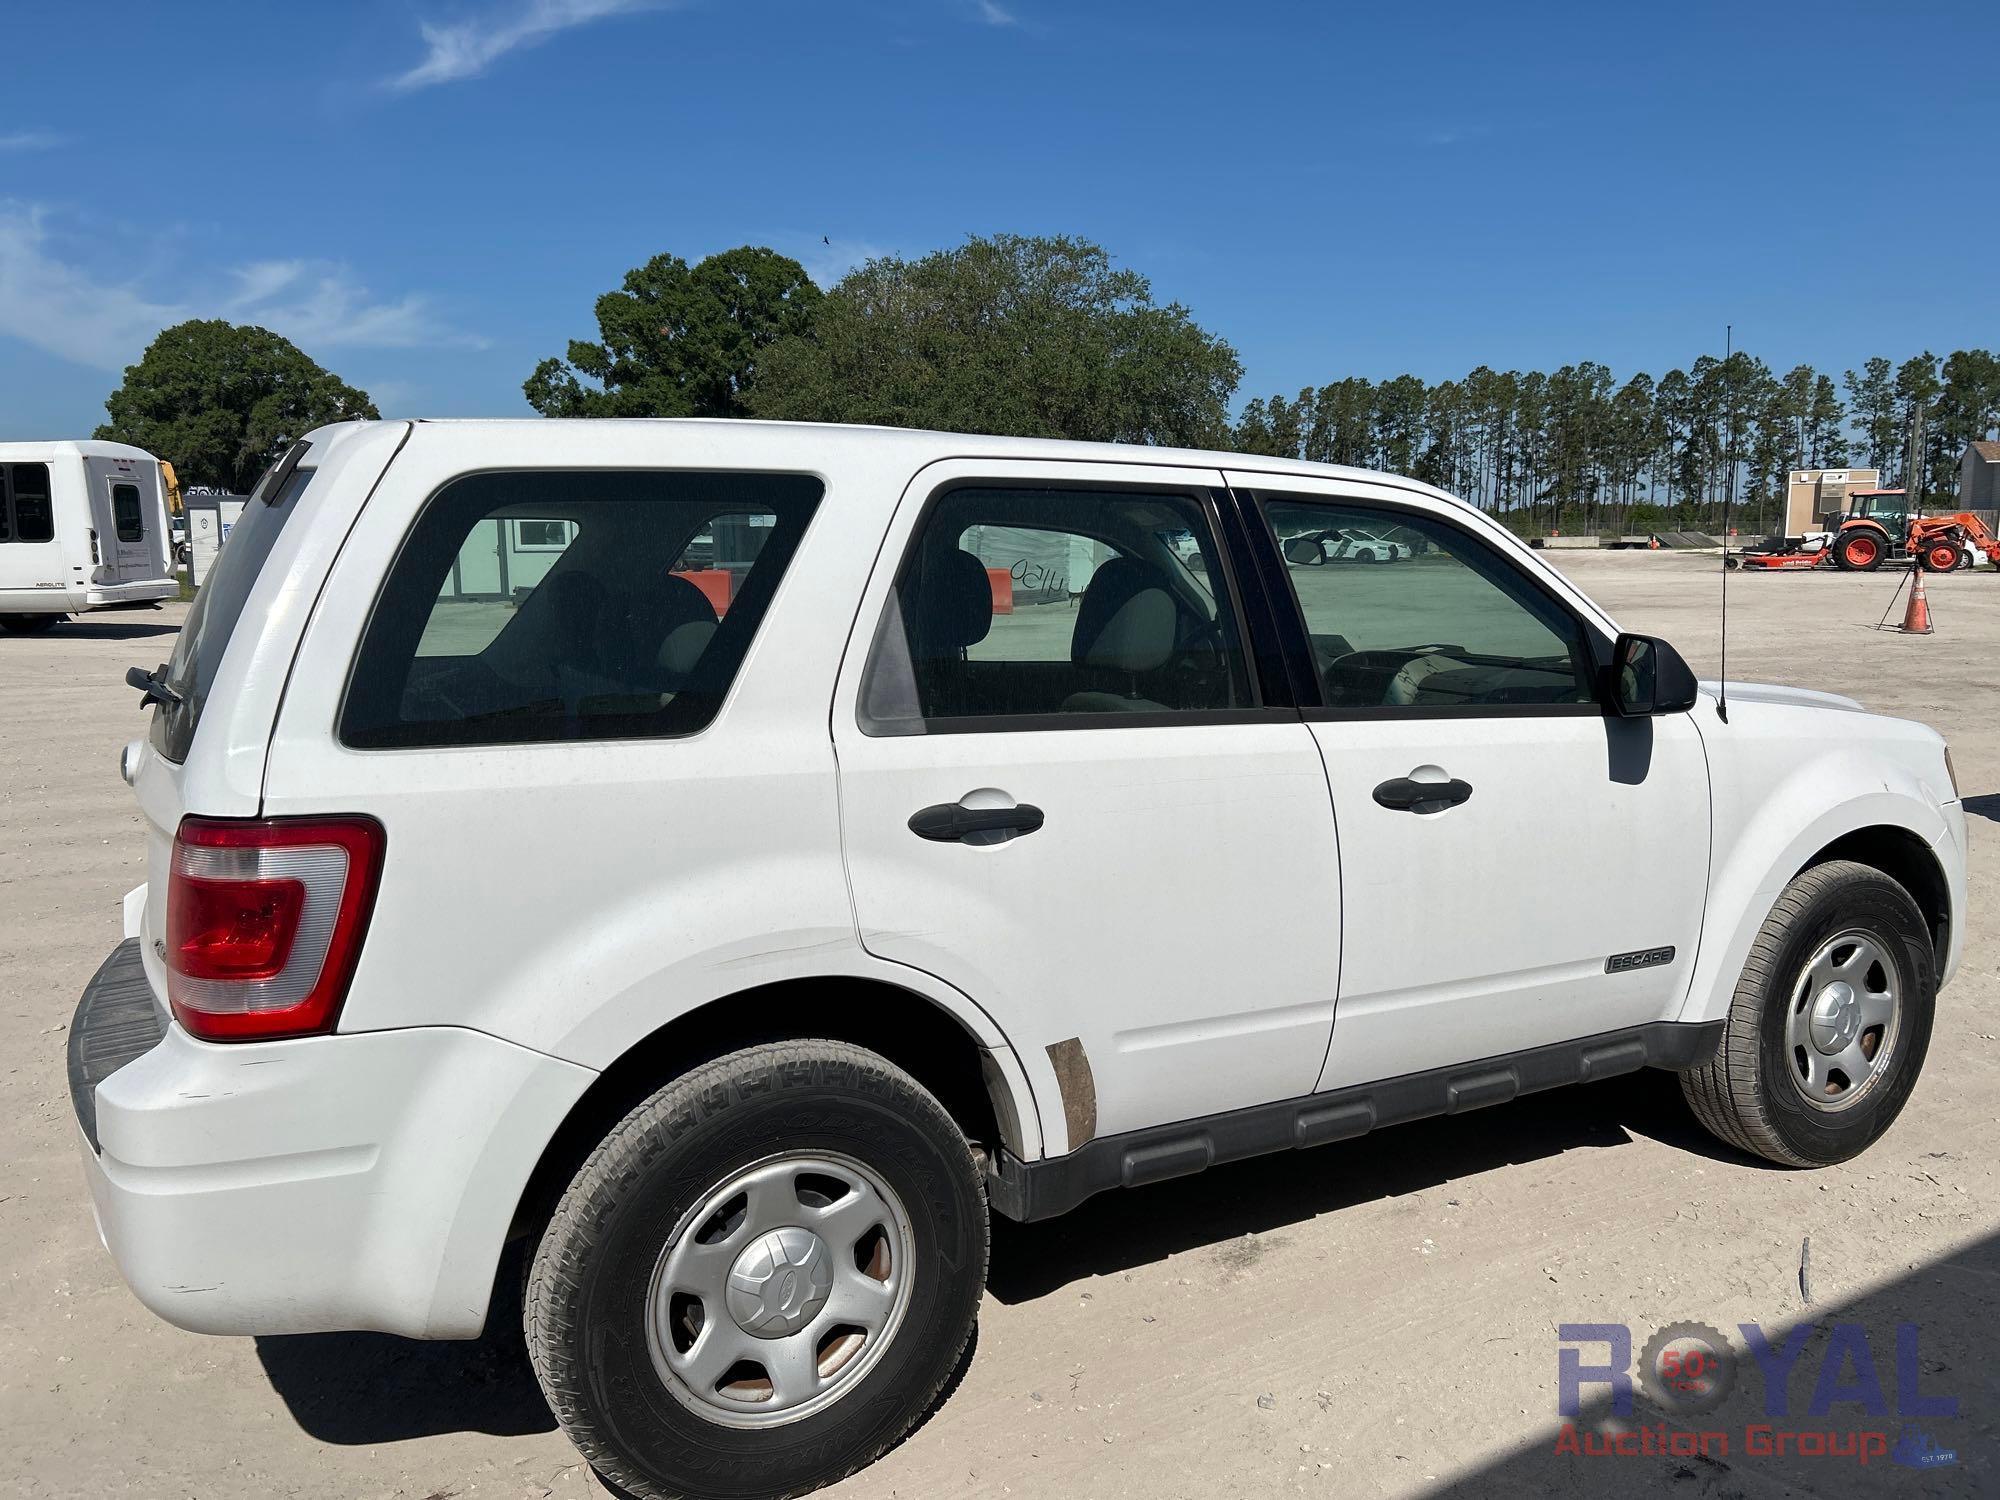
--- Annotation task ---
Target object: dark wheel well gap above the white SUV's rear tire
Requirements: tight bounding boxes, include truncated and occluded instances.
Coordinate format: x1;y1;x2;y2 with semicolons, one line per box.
498;978;1020;1238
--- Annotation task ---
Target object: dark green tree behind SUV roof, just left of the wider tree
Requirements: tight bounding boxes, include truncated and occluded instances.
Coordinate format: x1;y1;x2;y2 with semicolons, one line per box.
522;244;820;416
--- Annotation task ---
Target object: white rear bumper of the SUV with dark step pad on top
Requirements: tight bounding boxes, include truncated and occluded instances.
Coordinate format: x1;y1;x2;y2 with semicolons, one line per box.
72;942;596;1338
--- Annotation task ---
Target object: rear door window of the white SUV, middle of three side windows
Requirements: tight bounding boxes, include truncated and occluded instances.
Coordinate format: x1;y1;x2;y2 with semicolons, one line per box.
862;488;1252;734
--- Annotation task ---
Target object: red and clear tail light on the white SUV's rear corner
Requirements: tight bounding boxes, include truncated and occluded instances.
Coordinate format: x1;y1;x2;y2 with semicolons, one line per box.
166;818;384;1042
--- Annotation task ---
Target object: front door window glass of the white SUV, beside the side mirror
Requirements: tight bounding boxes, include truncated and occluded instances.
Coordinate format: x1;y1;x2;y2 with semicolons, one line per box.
1264;498;1592;710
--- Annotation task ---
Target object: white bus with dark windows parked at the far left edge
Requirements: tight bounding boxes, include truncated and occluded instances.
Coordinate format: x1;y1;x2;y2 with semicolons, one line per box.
0;442;180;632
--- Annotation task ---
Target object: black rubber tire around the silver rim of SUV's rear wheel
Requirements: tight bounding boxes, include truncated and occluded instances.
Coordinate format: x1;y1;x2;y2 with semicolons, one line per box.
524;1040;986;1498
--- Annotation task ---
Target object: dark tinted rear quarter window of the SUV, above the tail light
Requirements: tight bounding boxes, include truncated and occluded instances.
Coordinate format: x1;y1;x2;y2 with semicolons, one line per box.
340;470;820;750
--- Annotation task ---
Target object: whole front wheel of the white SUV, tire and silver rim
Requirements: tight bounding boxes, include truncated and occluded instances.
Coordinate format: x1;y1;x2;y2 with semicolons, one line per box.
1680;860;1938;1166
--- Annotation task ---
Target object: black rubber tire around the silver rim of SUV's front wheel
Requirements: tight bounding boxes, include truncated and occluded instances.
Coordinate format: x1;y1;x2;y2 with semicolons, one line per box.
1680;860;1938;1166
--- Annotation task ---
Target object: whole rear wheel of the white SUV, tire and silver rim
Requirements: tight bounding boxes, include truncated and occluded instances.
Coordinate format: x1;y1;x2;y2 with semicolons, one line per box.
526;1042;986;1496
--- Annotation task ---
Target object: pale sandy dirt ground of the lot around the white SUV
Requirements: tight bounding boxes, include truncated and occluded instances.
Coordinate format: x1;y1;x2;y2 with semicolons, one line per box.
0;554;2000;1500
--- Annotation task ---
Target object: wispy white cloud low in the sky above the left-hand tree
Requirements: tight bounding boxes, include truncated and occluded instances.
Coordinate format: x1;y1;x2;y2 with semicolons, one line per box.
0;200;484;370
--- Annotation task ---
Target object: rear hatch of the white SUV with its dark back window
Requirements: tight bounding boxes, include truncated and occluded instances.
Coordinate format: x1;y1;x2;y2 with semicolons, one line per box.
121;422;410;1006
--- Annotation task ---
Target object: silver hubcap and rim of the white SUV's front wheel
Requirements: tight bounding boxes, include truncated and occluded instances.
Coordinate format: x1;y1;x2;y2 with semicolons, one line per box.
1784;932;1902;1110
